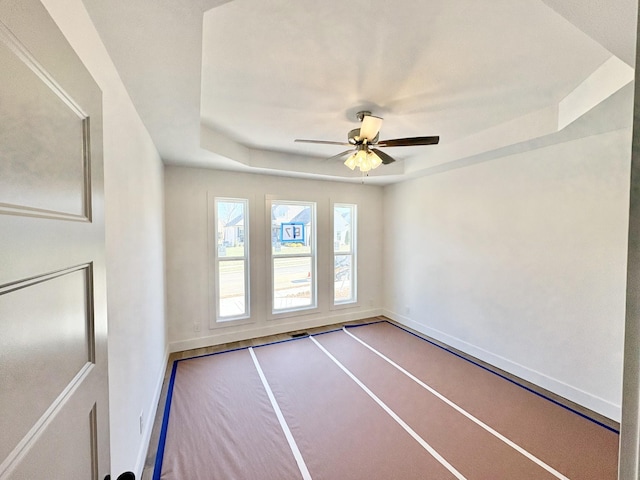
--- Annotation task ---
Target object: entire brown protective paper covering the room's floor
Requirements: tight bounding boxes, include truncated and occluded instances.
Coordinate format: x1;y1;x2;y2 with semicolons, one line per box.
154;322;618;480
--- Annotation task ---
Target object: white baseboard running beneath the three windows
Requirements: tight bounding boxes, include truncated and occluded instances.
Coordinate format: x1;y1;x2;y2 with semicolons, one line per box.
169;308;382;353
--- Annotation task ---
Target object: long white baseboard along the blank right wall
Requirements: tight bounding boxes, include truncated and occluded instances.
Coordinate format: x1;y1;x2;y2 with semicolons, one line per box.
383;309;622;422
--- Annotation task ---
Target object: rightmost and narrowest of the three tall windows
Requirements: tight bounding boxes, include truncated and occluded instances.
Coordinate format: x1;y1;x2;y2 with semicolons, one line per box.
333;203;357;305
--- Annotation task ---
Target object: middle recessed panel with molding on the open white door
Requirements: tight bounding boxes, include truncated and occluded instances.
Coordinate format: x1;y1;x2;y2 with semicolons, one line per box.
0;264;95;466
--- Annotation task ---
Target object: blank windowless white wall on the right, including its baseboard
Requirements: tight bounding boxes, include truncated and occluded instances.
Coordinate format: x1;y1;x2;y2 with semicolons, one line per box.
384;129;631;420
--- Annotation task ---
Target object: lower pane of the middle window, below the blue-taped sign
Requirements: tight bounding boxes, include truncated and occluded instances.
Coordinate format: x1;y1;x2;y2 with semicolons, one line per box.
273;257;313;311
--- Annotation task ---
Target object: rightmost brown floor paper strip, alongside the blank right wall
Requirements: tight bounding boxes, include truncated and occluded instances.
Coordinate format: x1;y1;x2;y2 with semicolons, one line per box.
349;322;619;480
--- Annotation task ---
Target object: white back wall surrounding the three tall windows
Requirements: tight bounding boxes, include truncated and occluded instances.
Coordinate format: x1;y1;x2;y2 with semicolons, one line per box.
165;166;384;351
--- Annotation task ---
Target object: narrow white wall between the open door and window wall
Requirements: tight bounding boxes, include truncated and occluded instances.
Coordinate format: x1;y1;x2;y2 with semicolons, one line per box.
43;0;167;478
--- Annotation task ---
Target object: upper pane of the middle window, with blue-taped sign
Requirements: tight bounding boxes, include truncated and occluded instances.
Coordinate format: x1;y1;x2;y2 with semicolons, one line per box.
271;203;313;256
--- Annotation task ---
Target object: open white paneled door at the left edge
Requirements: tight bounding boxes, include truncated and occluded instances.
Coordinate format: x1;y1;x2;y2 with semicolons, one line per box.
0;0;109;480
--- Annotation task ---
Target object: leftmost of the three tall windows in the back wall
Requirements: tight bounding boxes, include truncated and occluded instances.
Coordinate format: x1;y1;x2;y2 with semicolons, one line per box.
214;198;249;322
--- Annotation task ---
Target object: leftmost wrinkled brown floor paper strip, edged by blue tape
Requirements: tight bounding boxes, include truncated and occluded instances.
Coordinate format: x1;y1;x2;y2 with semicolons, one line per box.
160;350;302;480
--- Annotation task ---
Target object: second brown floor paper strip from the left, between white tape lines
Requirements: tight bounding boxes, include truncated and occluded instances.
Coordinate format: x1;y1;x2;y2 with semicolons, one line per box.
255;338;455;480
